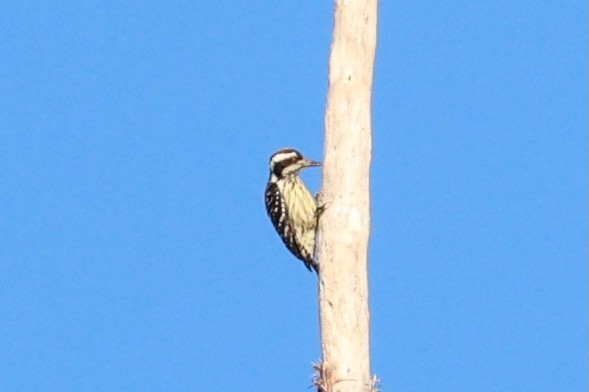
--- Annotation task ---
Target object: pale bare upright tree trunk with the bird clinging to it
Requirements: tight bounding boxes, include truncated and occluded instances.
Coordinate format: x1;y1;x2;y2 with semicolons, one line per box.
316;0;377;392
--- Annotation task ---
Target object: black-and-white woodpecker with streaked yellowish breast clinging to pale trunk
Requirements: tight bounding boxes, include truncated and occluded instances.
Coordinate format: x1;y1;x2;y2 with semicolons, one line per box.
265;148;321;272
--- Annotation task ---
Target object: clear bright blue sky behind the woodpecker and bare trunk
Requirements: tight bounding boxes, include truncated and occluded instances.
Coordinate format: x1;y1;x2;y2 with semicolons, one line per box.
0;0;588;392
